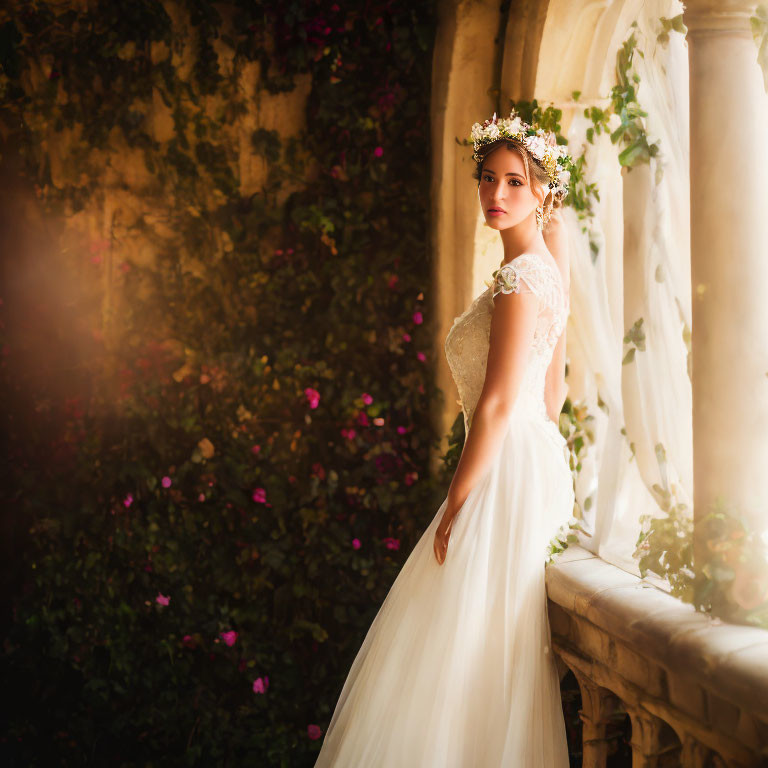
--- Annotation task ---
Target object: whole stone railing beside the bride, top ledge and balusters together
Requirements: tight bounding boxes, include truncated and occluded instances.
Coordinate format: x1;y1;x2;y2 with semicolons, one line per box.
547;546;768;768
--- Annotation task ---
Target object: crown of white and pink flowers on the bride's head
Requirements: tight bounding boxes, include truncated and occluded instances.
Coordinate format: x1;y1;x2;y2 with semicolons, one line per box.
470;109;572;200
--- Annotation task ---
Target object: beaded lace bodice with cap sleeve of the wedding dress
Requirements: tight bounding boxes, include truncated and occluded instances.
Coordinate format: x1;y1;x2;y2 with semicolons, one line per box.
445;253;568;431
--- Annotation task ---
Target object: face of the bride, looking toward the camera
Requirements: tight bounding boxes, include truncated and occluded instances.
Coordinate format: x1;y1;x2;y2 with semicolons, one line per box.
478;144;541;230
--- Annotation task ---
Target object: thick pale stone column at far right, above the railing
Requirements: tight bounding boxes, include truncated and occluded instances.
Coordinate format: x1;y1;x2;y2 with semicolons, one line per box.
683;0;768;544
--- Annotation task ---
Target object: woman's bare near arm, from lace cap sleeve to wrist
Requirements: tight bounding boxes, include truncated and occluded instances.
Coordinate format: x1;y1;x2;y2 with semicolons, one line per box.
444;290;539;520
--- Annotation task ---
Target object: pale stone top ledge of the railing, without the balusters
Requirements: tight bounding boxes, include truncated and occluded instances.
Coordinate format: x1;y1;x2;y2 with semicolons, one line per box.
546;546;768;765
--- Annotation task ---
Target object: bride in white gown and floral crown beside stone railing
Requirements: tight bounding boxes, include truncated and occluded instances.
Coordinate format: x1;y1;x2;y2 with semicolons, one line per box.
315;111;574;768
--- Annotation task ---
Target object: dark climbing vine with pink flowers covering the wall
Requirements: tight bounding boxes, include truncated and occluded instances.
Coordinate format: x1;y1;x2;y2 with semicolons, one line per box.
0;0;447;766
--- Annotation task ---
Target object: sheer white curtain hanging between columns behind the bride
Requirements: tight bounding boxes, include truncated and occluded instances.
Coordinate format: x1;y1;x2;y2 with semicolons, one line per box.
565;0;693;573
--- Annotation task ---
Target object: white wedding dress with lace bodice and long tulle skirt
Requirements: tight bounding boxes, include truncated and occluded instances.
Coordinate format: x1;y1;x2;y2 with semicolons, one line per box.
315;253;574;768
